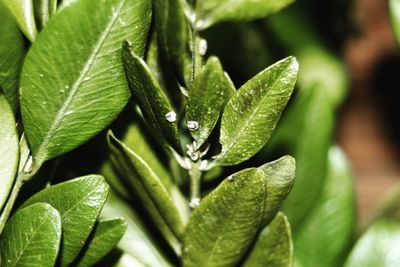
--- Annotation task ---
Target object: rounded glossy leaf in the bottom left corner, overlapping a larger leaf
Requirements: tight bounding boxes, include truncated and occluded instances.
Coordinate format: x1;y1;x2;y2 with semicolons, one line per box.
0;203;61;267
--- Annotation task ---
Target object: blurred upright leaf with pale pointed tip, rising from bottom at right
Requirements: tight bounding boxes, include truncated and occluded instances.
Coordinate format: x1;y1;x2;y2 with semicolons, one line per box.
294;147;357;267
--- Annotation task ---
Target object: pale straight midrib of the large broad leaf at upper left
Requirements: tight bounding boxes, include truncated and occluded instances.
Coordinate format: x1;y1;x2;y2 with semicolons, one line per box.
35;0;127;165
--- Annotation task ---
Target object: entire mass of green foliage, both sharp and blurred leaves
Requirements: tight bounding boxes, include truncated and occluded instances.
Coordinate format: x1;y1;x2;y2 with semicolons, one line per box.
0;0;400;267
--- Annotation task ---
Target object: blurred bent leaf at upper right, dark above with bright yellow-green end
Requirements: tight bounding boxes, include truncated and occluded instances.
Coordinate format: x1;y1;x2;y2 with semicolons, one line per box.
265;8;350;108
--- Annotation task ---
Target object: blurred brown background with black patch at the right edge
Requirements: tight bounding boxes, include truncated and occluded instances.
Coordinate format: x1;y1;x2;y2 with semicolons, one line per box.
338;0;400;222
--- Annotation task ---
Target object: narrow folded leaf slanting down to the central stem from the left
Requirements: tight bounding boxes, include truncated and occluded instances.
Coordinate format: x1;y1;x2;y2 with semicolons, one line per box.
108;133;184;241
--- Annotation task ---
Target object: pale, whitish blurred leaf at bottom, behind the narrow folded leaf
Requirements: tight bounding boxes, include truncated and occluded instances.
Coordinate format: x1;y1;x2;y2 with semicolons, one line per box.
101;194;172;266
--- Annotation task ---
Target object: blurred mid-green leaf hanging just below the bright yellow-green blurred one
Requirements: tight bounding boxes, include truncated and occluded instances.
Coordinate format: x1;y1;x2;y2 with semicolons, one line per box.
277;84;334;232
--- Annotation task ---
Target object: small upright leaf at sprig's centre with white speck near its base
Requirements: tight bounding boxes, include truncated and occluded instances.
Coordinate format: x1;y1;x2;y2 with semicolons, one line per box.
186;57;236;149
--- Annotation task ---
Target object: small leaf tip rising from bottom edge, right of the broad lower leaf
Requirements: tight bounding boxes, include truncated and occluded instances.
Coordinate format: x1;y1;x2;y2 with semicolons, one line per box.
243;212;293;267
